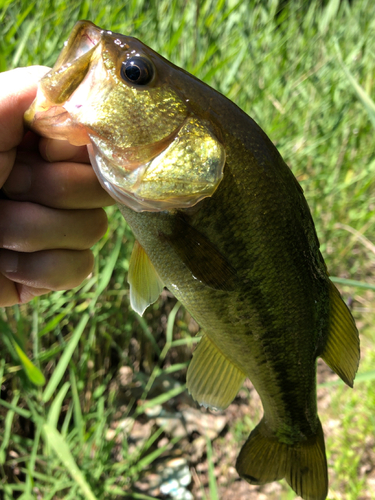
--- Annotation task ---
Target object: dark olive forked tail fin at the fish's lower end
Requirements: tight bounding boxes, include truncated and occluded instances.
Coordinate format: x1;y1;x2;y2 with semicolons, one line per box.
236;418;328;500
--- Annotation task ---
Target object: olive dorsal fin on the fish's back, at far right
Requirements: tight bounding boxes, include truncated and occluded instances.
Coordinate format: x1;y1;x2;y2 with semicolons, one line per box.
321;281;360;387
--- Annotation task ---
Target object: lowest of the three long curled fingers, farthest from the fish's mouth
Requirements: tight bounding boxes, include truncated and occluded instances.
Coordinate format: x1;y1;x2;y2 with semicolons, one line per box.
0;250;94;292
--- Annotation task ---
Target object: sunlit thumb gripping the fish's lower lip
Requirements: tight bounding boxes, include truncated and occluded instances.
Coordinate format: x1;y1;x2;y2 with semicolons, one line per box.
0;66;49;187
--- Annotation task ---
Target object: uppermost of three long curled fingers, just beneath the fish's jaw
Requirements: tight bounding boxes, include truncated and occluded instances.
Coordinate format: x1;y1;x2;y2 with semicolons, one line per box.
4;152;115;208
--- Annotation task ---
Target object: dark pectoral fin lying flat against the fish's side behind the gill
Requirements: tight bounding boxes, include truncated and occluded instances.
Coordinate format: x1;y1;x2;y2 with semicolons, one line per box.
161;217;236;291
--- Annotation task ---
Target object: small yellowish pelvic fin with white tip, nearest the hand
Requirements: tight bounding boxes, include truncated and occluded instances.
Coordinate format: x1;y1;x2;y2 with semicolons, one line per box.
128;240;164;316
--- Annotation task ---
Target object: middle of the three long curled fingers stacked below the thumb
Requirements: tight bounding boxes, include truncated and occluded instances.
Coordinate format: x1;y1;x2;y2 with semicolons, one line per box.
0;200;107;252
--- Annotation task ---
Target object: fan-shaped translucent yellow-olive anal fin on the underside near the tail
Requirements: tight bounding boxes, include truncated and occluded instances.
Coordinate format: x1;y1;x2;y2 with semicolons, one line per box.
186;335;246;410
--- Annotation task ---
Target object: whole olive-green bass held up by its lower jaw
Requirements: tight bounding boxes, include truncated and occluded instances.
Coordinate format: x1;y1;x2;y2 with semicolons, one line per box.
25;21;360;500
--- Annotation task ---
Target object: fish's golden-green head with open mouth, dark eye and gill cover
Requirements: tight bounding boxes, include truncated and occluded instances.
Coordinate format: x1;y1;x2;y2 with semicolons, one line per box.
25;21;225;212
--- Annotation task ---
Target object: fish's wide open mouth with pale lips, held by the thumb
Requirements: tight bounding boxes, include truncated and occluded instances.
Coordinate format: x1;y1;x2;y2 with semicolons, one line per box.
24;21;103;146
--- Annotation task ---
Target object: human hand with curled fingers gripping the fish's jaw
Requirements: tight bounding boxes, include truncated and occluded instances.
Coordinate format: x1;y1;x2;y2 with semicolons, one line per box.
0;66;114;307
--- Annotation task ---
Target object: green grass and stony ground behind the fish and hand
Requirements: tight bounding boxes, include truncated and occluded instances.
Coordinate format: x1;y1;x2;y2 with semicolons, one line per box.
0;0;375;500
